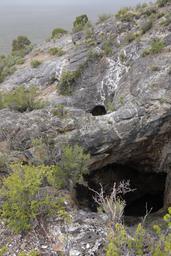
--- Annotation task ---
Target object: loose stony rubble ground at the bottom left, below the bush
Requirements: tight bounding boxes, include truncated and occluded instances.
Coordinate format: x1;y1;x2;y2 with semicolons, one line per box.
0;210;106;256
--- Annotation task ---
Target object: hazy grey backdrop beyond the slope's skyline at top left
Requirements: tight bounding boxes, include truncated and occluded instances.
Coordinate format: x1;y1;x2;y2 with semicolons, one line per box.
0;0;151;54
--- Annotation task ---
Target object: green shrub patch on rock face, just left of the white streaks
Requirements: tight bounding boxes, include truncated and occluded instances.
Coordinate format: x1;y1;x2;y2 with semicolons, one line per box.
58;69;81;95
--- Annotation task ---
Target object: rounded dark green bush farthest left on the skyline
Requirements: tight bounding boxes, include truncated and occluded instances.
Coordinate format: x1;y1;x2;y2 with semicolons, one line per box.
12;36;31;52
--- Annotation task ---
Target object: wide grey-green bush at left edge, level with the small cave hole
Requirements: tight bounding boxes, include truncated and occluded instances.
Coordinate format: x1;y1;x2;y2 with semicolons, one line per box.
0;86;44;112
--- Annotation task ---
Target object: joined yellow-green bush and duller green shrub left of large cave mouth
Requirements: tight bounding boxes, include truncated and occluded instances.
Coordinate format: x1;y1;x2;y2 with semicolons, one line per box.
0;145;90;234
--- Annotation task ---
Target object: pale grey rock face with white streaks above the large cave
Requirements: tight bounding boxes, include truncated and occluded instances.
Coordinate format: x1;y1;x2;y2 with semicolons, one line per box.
0;1;171;255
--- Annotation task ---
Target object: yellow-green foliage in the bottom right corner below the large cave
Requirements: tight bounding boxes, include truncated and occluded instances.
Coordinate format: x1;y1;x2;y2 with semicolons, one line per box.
106;208;171;256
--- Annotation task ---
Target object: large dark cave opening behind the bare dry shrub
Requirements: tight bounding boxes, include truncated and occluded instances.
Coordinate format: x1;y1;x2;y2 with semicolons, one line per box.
76;164;166;216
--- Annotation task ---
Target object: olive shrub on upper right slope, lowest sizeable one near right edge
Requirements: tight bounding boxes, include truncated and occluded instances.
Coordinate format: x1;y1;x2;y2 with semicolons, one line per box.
142;38;165;56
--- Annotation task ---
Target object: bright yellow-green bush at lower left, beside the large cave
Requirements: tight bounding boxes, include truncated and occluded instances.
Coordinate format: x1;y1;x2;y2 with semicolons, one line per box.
0;164;65;233
